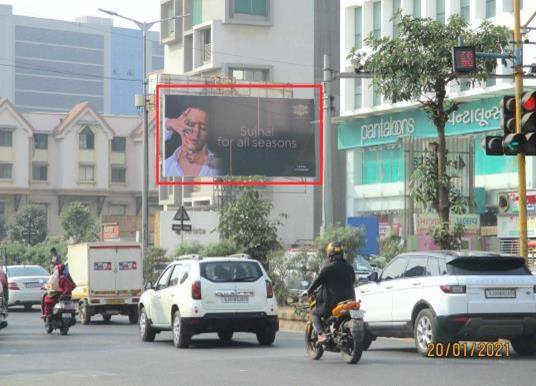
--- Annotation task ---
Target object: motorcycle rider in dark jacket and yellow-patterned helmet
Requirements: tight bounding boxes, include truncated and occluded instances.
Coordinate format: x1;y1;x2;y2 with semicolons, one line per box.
307;241;355;343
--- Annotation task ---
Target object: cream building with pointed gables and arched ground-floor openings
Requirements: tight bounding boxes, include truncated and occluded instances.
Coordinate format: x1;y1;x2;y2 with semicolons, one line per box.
0;99;159;239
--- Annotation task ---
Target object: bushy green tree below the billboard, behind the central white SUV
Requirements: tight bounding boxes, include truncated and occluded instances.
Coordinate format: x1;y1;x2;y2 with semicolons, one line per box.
218;188;285;269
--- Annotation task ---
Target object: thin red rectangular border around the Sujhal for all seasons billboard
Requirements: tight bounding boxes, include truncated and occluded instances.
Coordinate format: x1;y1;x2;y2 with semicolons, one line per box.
155;83;324;186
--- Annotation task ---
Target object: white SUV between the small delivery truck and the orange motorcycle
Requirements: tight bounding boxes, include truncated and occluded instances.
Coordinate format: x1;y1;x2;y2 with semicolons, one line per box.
139;255;279;348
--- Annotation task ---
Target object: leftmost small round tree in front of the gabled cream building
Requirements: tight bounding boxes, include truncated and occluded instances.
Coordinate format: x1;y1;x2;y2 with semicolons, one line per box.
8;205;47;245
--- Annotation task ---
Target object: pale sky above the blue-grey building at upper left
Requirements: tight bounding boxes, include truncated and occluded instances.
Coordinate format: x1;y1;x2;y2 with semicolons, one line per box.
0;0;160;31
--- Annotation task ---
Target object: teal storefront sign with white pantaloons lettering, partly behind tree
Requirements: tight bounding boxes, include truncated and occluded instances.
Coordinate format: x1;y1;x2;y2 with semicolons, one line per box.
339;98;501;150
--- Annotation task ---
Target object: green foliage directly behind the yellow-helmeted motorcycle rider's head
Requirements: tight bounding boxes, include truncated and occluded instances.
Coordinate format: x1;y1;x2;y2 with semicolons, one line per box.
315;226;365;264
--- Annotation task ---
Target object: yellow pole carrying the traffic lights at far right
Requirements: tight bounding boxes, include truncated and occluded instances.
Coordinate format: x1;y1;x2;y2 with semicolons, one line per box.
514;0;528;259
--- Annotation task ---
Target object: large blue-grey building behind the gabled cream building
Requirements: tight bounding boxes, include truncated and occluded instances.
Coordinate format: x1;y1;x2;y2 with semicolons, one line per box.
0;5;164;115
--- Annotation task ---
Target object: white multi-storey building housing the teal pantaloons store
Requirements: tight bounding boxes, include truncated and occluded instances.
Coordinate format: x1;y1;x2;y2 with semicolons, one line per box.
338;0;536;249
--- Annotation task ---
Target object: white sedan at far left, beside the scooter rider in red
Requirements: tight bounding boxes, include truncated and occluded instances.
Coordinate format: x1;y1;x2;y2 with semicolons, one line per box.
6;265;50;310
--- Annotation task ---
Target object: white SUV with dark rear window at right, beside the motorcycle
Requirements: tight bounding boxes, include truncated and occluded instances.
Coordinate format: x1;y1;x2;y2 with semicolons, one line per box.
356;251;536;355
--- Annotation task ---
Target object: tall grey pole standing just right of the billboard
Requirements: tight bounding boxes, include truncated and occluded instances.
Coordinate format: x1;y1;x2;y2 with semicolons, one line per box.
321;55;333;233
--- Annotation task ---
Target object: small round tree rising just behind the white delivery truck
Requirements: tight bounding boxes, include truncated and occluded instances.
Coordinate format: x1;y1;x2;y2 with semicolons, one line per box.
60;202;99;243
